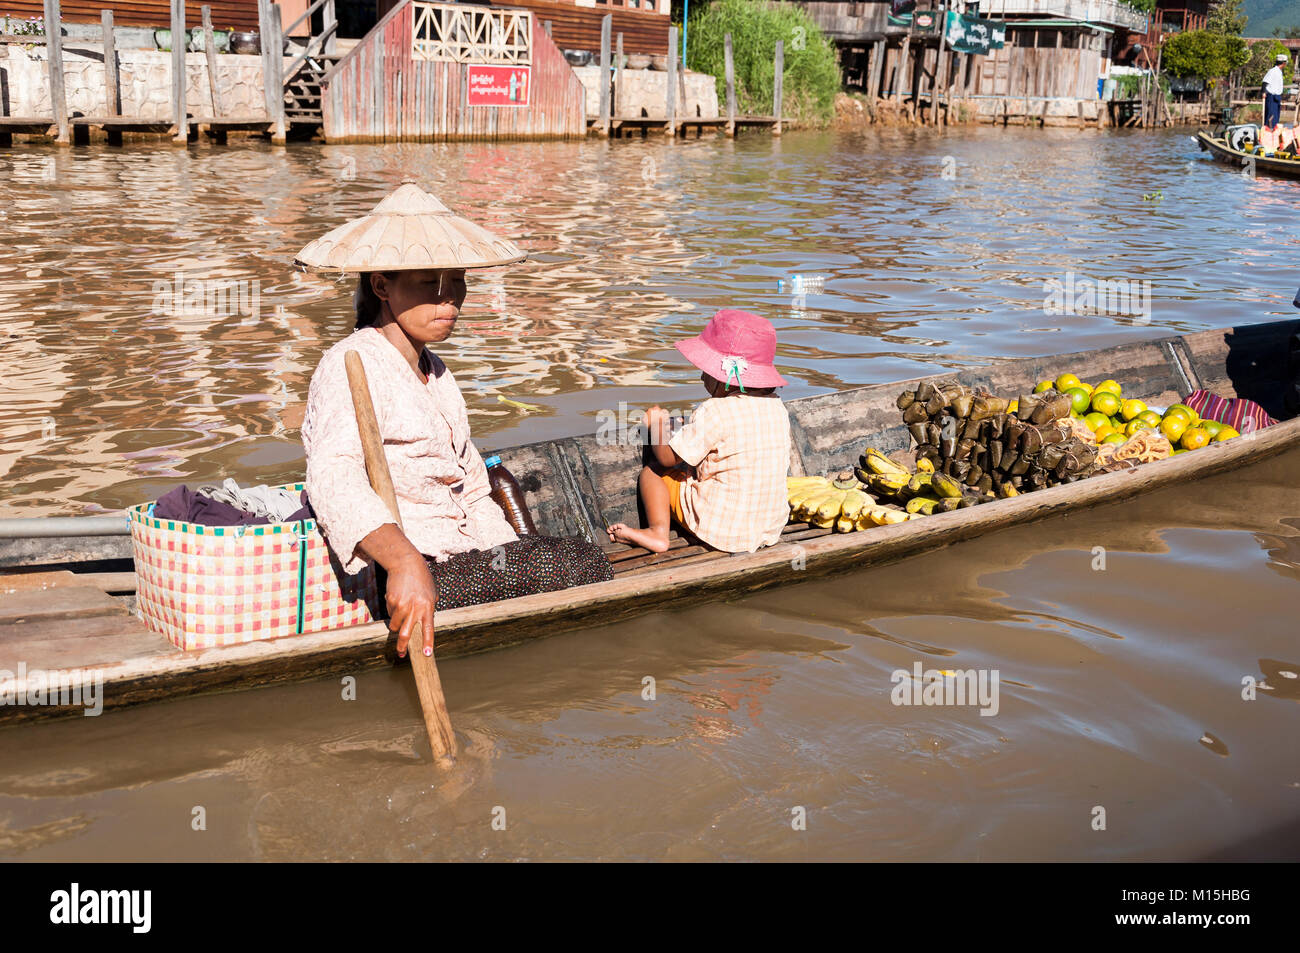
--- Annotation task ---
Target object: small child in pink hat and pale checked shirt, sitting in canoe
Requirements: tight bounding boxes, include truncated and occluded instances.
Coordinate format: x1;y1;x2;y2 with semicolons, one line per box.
608;311;790;553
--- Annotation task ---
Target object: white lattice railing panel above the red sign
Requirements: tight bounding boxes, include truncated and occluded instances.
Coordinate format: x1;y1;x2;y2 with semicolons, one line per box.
411;3;533;66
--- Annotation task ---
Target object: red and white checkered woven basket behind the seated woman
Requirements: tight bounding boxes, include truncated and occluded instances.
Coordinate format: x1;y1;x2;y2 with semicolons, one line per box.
127;484;381;650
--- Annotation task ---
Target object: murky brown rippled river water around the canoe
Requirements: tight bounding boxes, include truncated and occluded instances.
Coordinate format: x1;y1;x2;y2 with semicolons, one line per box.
0;130;1300;861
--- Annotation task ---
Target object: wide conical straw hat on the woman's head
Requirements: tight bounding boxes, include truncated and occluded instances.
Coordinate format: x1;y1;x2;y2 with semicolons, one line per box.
294;182;527;272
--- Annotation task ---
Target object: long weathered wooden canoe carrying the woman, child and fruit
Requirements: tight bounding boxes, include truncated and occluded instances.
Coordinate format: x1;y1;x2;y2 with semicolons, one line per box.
0;321;1300;722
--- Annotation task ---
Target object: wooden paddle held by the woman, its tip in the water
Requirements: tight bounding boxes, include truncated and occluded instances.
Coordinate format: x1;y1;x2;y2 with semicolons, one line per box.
343;351;456;766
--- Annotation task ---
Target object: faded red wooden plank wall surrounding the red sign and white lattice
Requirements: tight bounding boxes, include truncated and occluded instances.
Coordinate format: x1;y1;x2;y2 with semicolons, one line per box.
321;0;586;143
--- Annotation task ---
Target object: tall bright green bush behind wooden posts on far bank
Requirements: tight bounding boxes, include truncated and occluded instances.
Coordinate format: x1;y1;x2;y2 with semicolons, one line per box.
686;0;840;125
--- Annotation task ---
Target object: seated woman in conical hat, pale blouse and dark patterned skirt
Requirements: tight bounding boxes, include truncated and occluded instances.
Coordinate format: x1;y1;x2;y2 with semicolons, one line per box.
295;182;612;655
